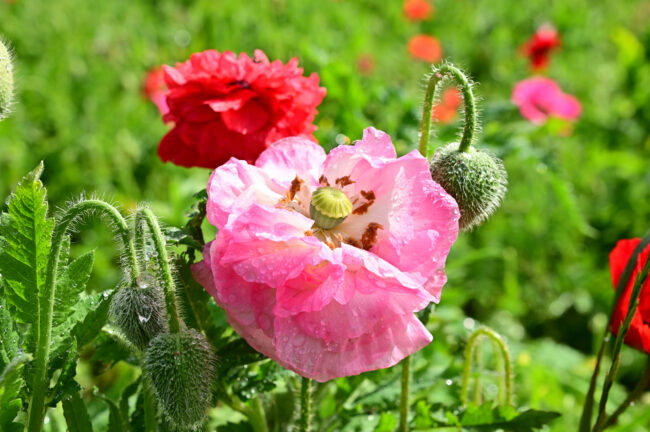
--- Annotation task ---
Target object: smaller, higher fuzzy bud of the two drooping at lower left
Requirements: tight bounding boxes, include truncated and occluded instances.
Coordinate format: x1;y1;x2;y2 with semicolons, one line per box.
109;275;169;349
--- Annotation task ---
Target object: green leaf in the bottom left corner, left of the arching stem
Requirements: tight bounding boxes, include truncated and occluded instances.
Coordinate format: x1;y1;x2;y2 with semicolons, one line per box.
0;354;31;431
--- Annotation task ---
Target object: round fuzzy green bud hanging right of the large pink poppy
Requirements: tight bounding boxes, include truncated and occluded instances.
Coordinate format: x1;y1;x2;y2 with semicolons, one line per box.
430;143;508;230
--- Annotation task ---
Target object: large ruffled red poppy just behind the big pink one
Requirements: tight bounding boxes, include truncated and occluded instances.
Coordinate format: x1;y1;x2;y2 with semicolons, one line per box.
158;50;325;168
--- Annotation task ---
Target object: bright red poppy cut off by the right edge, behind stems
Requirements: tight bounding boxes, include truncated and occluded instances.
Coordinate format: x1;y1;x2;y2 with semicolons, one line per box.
609;238;650;354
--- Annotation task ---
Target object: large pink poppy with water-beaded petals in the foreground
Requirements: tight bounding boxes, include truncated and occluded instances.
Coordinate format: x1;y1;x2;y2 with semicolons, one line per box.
193;128;460;382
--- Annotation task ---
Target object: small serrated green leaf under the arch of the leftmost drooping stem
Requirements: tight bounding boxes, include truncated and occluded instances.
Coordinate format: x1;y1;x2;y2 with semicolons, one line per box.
54;251;95;326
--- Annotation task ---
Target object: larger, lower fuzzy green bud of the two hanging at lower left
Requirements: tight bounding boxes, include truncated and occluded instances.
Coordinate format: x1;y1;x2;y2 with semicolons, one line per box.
143;329;214;429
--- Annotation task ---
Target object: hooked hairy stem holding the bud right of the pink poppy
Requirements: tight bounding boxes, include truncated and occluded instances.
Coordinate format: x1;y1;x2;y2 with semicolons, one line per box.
419;63;477;159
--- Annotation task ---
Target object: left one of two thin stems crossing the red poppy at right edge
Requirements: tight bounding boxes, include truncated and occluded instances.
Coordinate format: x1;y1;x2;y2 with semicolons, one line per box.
578;232;650;432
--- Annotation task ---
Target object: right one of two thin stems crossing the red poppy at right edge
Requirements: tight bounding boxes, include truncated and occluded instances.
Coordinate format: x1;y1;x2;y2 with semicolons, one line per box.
594;255;650;432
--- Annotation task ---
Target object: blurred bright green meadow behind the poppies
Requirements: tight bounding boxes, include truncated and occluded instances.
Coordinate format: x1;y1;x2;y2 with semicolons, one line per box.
0;0;650;431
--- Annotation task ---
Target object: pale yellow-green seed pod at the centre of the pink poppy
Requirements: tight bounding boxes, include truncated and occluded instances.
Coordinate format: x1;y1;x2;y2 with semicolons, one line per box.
309;186;352;229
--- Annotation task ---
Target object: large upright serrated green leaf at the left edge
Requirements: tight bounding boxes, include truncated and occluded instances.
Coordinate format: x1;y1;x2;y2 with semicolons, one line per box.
0;162;54;323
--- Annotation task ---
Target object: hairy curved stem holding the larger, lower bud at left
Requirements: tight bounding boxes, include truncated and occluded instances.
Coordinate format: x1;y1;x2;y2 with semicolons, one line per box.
135;208;181;333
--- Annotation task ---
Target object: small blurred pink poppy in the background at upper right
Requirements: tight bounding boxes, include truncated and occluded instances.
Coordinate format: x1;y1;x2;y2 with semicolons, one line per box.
511;76;582;124
